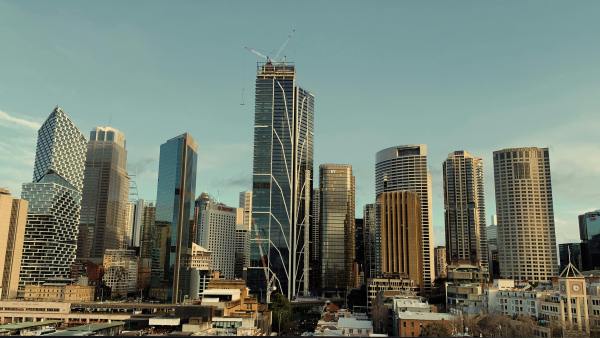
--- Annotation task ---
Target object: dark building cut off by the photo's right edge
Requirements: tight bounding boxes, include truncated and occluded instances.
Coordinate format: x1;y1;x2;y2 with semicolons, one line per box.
579;210;600;270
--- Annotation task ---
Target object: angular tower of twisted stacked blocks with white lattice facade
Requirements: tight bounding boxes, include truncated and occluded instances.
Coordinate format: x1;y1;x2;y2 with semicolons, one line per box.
19;107;87;291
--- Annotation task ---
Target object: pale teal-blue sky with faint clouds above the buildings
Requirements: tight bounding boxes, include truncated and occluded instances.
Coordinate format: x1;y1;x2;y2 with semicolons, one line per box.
0;1;600;244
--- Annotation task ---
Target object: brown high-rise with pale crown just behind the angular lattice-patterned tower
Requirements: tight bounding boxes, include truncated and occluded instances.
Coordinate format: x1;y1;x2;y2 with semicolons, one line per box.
77;127;129;263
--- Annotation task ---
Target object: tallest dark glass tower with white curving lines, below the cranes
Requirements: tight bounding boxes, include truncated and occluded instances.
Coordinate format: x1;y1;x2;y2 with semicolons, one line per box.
248;62;314;302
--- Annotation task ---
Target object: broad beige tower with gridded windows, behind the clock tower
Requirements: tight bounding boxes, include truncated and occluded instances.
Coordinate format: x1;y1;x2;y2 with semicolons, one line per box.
494;147;558;282
